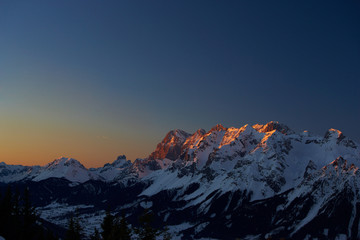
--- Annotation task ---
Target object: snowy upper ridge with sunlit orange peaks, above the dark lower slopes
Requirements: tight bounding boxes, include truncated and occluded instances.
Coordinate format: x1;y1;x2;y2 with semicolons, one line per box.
0;122;360;189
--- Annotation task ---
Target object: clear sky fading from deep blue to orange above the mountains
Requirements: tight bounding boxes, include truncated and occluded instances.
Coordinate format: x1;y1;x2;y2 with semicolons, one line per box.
0;0;360;167
